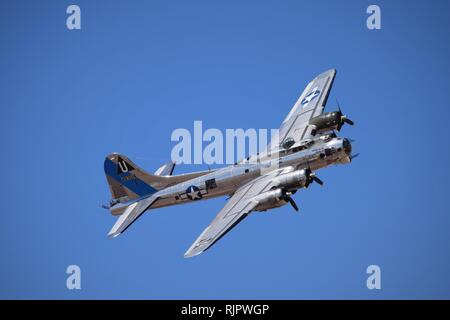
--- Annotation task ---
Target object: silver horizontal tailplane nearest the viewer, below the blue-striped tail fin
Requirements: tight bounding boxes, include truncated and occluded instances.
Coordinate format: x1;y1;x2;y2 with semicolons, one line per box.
108;195;158;238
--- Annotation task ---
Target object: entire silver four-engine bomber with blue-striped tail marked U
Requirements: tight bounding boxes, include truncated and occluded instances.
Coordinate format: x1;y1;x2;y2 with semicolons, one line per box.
104;69;355;257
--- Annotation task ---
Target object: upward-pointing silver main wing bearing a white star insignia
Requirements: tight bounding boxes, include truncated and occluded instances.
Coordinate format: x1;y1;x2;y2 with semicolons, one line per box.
269;69;336;150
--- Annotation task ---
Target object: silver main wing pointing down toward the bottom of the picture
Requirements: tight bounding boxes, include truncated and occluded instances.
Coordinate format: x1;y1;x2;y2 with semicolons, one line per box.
184;169;288;258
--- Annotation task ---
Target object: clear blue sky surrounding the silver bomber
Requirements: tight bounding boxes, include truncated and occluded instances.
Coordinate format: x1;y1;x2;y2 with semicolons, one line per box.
0;0;450;299
